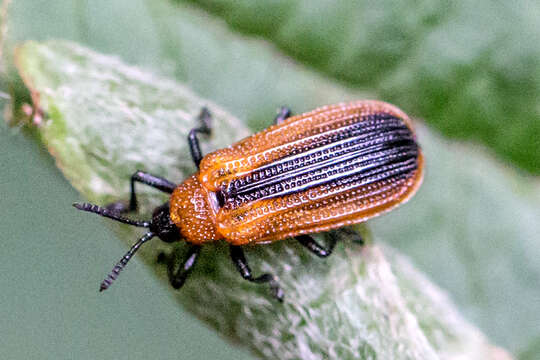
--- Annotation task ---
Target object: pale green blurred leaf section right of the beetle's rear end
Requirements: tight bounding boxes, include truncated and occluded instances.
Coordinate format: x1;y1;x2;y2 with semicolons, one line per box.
371;128;540;353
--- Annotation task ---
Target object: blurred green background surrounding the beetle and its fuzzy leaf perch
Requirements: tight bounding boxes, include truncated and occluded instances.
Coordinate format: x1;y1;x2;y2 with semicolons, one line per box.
0;0;540;359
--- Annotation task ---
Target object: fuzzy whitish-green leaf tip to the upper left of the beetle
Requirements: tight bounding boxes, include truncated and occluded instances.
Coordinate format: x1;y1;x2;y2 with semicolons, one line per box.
16;43;248;206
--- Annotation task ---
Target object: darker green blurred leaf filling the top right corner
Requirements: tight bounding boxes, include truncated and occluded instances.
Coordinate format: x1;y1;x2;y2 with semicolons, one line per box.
180;0;540;174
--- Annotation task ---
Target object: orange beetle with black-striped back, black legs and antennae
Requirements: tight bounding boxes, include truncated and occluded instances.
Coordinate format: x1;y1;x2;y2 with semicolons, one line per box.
73;100;424;301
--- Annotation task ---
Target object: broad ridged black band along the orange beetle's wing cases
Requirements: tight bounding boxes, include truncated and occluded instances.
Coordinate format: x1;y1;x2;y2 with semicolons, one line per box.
220;114;418;206
